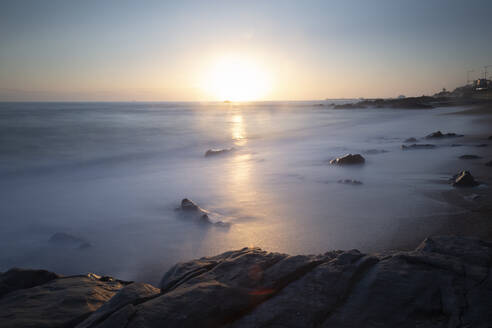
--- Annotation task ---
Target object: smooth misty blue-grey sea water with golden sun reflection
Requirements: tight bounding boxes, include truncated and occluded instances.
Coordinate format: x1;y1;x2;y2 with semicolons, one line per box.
0;101;484;283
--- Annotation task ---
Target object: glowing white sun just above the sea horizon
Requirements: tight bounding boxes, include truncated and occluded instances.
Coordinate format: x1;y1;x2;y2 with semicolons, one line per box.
203;56;270;101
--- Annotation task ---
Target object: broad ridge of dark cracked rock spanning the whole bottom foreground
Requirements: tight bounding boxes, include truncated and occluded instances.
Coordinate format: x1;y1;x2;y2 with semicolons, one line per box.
0;236;492;328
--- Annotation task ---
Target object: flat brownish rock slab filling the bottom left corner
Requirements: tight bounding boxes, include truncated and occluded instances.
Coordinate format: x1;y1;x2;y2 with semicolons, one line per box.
0;275;124;327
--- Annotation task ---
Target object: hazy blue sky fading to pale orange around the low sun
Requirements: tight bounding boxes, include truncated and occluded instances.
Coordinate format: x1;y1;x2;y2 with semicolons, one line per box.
0;0;492;101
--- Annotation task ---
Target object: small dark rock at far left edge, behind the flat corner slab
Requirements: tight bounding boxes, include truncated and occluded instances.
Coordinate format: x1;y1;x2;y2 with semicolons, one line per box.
0;268;60;297
